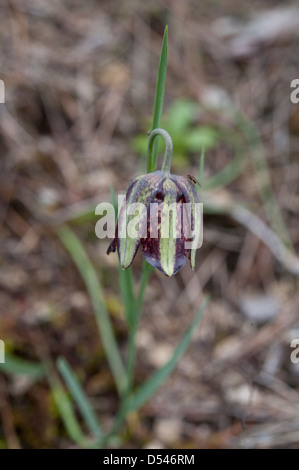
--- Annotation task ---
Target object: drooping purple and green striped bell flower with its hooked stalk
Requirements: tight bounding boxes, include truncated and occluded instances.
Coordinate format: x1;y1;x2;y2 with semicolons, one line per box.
107;129;202;277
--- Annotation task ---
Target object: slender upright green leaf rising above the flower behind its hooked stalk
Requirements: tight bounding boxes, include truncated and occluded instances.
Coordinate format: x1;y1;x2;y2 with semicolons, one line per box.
147;26;168;173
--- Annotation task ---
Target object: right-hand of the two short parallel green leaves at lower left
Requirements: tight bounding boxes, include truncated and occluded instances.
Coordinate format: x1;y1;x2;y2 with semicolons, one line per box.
57;357;103;437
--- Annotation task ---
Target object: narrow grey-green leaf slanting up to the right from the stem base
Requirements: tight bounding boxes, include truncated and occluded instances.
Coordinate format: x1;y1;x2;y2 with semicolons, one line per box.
127;298;208;412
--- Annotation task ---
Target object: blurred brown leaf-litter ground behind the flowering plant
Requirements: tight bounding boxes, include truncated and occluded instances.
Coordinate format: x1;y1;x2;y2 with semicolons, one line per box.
0;0;299;448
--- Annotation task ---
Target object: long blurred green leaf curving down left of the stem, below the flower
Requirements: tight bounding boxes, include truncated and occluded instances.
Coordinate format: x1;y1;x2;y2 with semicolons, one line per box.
58;226;127;394
